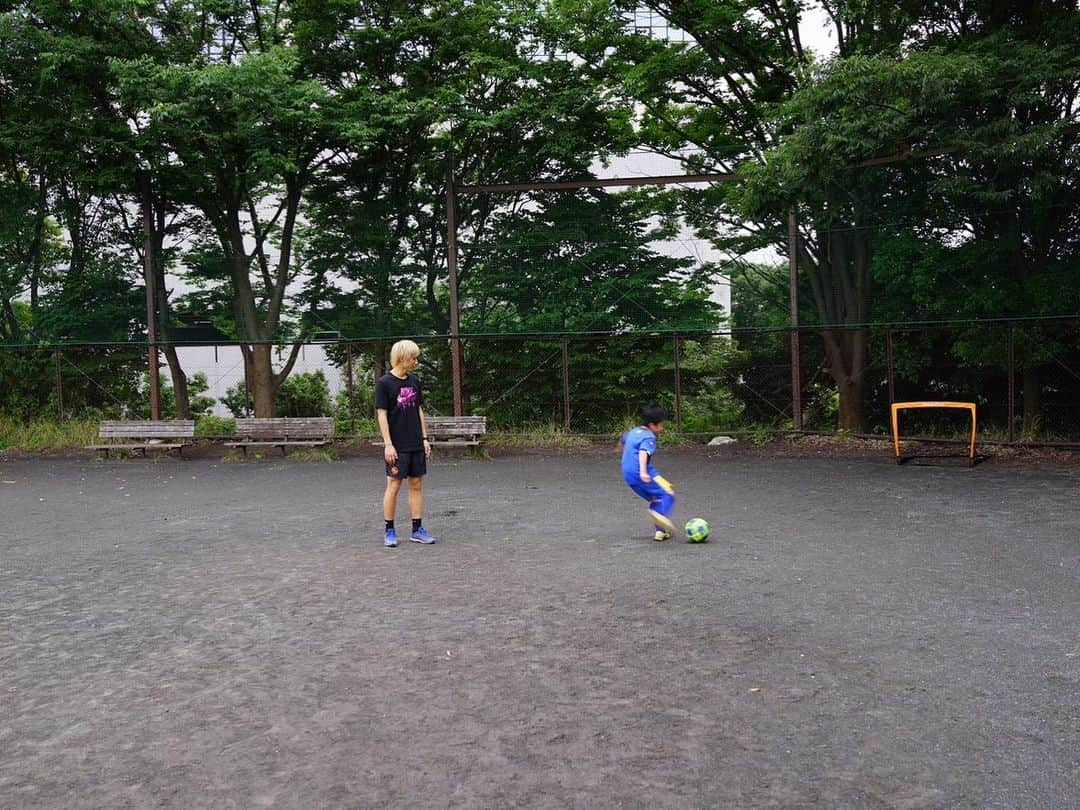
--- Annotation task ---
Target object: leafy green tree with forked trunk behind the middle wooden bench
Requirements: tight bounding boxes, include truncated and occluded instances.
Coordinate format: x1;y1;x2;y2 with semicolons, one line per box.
111;3;334;416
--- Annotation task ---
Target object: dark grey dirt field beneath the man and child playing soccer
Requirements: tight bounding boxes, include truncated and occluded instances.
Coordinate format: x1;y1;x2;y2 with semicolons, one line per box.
0;450;1080;809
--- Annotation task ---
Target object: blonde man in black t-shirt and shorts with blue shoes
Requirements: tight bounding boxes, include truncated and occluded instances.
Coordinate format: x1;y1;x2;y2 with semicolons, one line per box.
375;340;435;549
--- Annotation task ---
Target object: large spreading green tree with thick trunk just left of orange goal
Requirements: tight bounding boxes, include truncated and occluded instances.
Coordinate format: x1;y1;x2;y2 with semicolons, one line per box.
551;0;1077;429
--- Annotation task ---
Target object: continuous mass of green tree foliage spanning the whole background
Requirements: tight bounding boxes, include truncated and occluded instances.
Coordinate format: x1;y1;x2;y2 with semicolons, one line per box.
0;0;1080;438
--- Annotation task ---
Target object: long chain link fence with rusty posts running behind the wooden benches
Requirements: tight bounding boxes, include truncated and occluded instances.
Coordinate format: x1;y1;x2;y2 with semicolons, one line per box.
6;319;1080;444
